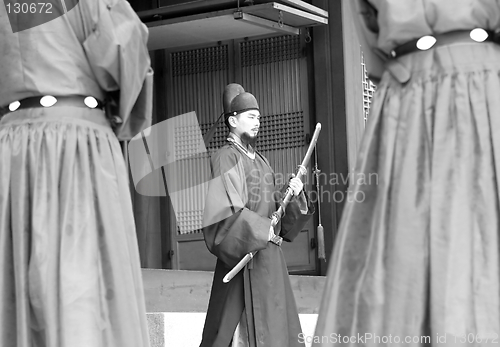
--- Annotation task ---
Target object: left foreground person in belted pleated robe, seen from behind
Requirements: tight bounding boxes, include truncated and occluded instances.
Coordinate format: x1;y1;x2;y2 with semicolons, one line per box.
0;0;152;347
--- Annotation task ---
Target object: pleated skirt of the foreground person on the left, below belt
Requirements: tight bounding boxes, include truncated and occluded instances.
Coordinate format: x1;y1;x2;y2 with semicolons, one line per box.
0;107;149;347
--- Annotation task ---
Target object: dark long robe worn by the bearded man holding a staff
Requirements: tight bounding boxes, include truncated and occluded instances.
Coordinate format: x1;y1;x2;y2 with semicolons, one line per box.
200;143;313;347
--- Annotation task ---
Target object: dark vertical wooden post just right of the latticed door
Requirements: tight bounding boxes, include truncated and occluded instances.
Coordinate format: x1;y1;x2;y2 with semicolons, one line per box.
312;0;350;275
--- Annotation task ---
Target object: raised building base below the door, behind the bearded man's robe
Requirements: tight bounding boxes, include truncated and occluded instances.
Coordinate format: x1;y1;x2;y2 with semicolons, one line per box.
142;269;325;347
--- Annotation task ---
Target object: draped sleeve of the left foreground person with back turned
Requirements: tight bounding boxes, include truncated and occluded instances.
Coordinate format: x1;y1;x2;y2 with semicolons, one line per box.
80;0;153;140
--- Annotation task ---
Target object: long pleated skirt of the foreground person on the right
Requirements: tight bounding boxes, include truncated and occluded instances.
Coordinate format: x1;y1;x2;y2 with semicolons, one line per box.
314;43;500;346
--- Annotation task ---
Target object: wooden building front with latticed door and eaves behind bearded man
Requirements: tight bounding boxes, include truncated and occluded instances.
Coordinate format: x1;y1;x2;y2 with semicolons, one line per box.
129;0;369;275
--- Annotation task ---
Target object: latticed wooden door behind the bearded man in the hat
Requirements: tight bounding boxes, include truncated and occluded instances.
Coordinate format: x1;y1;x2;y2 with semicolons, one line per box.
167;36;316;273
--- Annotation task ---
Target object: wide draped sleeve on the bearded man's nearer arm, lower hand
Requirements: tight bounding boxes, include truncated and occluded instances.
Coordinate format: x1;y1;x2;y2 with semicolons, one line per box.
203;148;271;267
